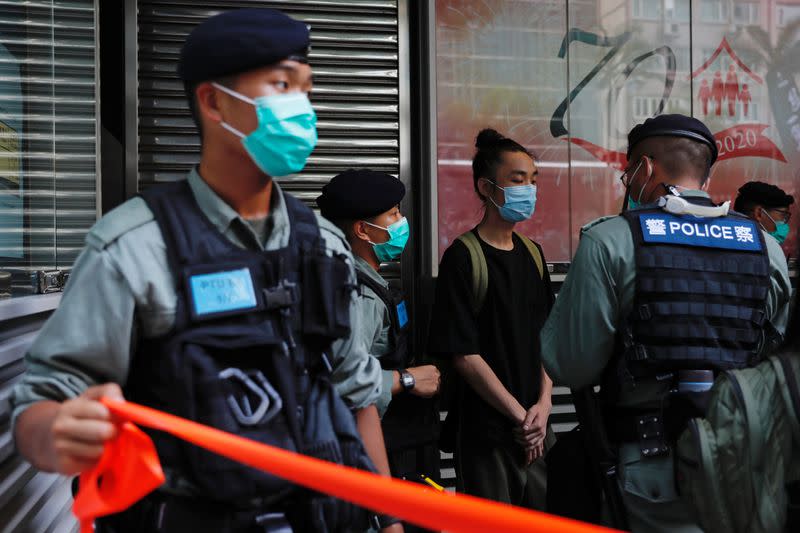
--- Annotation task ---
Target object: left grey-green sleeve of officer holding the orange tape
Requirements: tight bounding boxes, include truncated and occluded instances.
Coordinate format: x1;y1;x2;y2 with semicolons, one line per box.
11;246;135;421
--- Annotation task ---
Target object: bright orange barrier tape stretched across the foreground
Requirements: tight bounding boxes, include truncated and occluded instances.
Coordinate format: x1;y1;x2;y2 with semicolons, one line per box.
73;398;612;533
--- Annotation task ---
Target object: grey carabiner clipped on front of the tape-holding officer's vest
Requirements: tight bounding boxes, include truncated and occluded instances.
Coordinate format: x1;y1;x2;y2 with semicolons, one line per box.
218;368;283;426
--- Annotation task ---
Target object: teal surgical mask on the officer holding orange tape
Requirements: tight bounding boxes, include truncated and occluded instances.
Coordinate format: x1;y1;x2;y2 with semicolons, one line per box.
212;83;317;177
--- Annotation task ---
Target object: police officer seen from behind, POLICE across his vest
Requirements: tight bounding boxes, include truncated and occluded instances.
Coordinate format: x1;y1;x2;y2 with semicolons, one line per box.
542;115;791;532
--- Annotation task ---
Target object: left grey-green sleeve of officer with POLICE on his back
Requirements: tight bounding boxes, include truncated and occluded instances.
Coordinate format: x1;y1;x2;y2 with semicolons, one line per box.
541;233;620;388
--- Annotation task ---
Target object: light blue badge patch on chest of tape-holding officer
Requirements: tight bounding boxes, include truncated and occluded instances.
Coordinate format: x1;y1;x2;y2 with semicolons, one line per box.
189;268;256;316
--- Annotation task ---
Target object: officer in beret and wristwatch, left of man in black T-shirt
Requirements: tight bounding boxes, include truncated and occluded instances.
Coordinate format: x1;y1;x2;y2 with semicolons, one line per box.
317;169;440;530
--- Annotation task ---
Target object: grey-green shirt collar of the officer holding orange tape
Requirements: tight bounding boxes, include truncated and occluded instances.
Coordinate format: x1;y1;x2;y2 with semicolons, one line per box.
188;167;289;249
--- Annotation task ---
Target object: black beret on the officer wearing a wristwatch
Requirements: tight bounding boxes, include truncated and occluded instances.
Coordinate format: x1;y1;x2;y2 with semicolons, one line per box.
317;168;406;220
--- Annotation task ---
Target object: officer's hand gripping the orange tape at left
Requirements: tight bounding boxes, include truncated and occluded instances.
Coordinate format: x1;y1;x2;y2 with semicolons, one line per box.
50;383;123;475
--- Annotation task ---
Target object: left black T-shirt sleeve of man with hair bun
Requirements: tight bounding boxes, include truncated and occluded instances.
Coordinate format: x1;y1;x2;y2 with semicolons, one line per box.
428;241;480;358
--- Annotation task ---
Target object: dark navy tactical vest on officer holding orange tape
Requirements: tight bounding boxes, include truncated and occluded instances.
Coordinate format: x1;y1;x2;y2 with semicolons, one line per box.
125;181;374;531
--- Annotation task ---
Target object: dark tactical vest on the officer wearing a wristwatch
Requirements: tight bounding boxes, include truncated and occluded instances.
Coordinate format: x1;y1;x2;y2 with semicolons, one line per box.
356;269;438;448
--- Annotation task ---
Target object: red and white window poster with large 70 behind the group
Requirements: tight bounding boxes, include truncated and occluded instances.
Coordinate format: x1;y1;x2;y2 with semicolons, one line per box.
435;0;800;262
